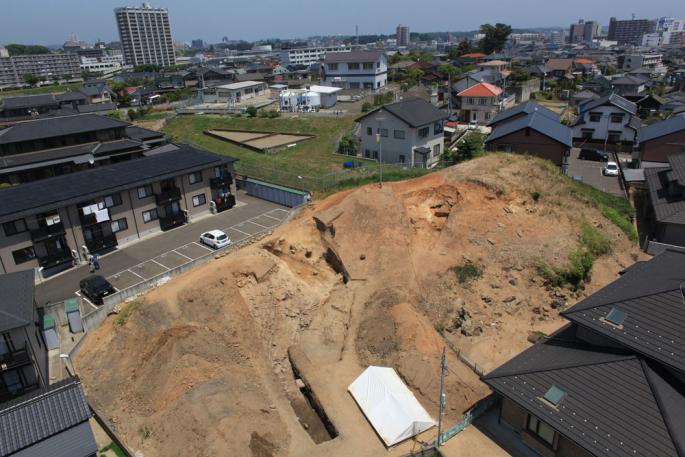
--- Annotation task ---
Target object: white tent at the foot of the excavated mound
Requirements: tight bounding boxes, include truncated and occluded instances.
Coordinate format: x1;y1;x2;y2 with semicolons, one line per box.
347;366;435;447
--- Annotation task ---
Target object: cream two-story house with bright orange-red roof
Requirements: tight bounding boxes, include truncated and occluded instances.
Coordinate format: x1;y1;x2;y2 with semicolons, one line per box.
457;83;514;124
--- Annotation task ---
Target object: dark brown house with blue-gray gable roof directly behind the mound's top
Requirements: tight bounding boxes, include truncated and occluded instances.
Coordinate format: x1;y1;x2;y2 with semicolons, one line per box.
485;104;573;173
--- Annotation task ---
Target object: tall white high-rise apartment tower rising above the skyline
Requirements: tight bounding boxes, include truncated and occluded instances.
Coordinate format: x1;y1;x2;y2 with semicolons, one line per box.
114;3;176;67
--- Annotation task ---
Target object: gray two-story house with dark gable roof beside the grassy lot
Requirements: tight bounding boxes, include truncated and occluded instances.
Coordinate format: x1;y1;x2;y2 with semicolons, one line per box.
357;98;447;168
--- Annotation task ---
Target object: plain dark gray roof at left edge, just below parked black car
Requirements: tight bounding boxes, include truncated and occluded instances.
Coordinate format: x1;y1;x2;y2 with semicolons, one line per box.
0;270;34;333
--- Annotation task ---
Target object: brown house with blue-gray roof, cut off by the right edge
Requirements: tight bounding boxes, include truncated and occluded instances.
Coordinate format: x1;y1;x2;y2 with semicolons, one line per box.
635;116;685;162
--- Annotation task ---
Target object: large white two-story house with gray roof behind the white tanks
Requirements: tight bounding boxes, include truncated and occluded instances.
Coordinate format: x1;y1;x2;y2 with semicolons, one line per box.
321;51;388;91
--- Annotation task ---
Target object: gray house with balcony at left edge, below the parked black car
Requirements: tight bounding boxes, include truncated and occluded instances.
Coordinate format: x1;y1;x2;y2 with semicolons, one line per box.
0;270;50;400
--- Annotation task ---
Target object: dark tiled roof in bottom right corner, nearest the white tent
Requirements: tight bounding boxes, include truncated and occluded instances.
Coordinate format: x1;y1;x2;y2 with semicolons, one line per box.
483;326;685;457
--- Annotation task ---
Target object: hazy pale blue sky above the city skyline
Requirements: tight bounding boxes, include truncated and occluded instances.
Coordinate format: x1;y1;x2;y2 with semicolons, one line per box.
0;0;685;45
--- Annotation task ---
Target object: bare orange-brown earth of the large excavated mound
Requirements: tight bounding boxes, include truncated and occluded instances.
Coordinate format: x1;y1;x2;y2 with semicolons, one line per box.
75;156;639;457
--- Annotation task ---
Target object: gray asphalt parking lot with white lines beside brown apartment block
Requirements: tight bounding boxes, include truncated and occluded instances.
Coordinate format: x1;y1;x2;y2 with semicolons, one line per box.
35;193;289;306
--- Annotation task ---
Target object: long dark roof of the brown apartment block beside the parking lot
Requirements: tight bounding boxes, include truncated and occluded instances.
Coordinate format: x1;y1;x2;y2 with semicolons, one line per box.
0;145;236;220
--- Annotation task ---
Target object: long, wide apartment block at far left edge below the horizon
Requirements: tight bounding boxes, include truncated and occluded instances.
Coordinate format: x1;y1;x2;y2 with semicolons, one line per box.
0;53;81;87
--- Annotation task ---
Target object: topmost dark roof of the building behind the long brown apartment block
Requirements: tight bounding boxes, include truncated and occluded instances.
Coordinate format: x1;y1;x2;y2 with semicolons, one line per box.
0;114;131;144
